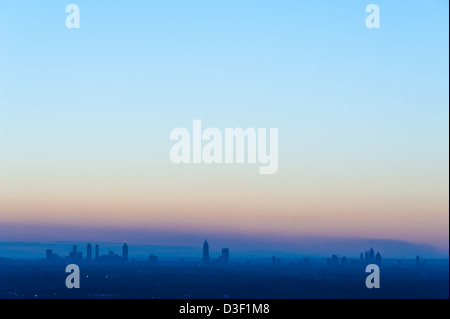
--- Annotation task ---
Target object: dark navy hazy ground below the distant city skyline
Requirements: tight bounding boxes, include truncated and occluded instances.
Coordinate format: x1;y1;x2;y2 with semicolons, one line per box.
0;261;449;299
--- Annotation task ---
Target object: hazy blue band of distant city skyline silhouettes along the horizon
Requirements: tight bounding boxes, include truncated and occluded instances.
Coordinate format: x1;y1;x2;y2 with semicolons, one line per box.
0;239;448;265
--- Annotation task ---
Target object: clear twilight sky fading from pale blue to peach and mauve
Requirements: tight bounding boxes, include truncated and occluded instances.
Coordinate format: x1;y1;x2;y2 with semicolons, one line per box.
0;0;449;256
